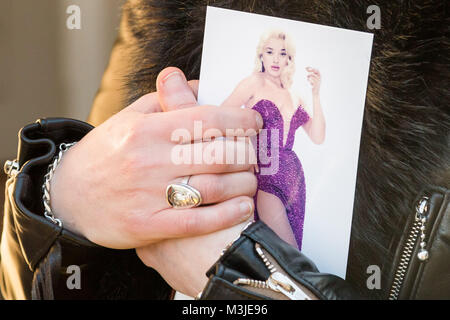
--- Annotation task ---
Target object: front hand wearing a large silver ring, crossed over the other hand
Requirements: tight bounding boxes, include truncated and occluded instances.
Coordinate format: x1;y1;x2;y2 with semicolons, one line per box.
50;67;262;249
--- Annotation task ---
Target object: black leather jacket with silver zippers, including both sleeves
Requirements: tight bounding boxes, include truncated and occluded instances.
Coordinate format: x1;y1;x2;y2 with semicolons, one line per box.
0;119;450;299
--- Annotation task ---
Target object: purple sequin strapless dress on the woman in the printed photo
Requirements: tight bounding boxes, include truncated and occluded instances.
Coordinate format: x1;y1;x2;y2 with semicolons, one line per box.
252;100;309;249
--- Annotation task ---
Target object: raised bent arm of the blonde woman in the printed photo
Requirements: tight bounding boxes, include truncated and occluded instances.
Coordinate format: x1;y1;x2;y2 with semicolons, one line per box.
303;67;325;144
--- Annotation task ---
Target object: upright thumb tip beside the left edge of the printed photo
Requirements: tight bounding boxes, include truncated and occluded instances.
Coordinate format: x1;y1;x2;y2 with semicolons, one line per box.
156;67;197;111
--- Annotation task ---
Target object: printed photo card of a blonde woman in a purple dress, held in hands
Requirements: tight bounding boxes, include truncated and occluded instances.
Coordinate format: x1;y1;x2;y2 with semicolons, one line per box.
198;7;373;277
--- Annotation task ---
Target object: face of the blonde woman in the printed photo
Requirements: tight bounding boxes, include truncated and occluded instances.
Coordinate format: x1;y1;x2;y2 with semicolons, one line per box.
261;38;288;77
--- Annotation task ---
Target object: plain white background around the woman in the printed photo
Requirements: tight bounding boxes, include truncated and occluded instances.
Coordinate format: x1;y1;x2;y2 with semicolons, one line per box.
199;7;373;278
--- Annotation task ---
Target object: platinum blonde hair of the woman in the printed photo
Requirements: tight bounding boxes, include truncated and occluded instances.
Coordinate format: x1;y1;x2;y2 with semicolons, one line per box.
255;29;295;89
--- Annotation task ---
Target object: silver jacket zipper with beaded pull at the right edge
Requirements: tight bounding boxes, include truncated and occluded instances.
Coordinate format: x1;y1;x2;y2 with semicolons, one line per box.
389;196;429;300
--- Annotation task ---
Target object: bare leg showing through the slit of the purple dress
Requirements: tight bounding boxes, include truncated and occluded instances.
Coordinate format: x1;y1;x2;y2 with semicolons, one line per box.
256;190;298;249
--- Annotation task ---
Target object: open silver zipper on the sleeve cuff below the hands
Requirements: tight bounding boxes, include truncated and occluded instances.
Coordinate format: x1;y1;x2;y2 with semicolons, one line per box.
233;243;311;300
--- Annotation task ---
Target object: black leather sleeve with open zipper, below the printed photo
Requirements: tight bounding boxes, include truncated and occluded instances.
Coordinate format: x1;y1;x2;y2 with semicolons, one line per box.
200;221;365;300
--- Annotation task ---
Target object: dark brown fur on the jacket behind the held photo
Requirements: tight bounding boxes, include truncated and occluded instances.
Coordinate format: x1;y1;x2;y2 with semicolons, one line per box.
124;0;450;297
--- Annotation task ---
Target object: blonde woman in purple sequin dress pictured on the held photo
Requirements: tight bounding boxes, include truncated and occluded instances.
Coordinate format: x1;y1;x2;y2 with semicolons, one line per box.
221;30;325;249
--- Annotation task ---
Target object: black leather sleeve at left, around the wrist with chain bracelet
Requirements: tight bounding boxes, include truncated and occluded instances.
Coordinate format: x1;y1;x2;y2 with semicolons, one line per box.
0;118;172;299
